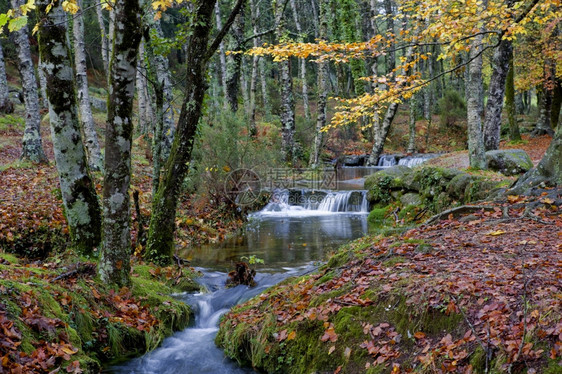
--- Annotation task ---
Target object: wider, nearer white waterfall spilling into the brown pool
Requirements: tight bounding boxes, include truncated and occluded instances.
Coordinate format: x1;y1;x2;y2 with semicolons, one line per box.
257;189;369;215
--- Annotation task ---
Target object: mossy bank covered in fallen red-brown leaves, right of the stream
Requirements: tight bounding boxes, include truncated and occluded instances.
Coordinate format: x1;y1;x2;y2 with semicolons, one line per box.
216;190;562;373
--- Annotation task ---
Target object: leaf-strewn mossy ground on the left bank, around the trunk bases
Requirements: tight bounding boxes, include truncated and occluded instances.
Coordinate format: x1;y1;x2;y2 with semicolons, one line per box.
0;101;243;373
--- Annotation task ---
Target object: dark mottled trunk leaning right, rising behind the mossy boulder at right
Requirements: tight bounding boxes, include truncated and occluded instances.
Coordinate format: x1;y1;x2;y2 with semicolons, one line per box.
484;39;513;151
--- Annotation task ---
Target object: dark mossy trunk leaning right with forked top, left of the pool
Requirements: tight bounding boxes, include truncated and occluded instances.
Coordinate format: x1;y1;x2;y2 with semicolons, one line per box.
145;0;243;264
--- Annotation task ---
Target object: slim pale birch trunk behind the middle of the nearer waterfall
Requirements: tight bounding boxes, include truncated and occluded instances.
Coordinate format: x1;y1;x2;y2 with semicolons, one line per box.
308;0;328;167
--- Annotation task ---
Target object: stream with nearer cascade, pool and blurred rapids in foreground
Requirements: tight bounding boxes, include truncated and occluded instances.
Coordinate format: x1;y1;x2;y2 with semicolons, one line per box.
110;190;368;374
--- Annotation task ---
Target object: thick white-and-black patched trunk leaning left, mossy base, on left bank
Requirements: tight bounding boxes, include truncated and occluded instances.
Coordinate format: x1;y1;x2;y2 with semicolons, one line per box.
36;0;101;254
